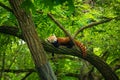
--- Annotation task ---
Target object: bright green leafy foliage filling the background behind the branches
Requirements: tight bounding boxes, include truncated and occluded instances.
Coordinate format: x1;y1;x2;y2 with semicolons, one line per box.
0;0;120;80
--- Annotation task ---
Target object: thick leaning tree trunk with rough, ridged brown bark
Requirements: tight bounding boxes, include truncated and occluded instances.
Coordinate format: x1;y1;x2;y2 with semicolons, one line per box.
9;0;57;80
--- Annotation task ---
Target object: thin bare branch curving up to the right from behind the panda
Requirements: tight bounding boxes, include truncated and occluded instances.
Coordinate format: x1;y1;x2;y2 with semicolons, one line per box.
73;18;115;39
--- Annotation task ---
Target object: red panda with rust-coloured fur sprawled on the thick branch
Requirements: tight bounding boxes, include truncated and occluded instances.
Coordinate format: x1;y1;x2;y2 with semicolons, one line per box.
47;35;86;56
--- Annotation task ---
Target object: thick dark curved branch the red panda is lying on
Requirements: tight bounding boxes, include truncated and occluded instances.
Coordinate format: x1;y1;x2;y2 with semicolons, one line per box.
0;26;119;80
